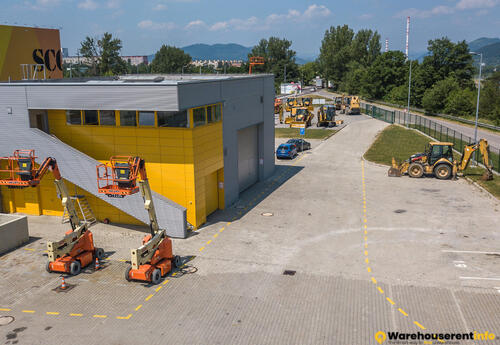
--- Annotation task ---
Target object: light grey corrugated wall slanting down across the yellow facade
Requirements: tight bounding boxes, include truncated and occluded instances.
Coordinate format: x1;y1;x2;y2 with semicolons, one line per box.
0;85;187;238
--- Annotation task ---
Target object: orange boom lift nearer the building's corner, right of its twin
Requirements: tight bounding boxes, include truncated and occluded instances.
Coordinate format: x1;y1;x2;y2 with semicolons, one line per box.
97;156;182;284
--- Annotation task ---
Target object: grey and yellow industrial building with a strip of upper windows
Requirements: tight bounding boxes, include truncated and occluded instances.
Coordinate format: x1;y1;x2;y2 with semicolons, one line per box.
0;75;274;237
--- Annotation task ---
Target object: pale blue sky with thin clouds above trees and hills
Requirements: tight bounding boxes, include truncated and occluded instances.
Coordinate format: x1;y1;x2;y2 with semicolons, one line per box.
0;0;500;57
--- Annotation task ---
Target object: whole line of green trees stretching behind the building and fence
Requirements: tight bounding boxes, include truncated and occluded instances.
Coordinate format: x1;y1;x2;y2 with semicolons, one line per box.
71;29;500;125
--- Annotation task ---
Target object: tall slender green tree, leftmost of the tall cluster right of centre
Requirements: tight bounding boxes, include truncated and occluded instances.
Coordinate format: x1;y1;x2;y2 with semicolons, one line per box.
318;25;354;85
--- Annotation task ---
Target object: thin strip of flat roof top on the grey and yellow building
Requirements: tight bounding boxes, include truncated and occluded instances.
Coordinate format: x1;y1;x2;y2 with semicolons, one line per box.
0;74;273;86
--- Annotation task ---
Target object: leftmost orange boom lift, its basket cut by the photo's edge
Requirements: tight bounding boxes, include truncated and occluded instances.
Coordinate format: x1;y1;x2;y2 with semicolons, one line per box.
0;150;104;275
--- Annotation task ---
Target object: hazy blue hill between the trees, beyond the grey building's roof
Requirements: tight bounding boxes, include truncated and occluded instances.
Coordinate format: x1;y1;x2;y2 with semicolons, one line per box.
181;43;252;60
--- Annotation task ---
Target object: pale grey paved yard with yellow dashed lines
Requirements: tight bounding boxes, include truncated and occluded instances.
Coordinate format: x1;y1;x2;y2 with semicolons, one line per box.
0;116;500;345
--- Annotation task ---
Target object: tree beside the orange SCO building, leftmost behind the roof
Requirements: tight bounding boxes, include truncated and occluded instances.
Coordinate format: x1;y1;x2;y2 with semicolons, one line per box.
80;32;127;75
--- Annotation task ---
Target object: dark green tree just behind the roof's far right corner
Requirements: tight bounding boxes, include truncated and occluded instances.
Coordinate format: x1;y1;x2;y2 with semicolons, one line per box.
248;37;299;87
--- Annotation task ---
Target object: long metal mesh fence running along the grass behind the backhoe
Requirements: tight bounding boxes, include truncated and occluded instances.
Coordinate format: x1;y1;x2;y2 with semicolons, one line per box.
361;103;500;172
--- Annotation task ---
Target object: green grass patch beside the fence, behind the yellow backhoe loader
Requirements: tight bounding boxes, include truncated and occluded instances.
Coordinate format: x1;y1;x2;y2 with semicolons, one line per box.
365;125;500;199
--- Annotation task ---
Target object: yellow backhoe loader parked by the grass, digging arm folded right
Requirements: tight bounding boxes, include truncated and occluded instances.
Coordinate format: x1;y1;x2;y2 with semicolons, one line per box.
387;139;493;181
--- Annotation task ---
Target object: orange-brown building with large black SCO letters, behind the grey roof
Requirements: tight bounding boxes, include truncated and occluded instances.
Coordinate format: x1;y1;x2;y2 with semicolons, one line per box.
0;25;63;81
